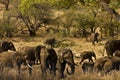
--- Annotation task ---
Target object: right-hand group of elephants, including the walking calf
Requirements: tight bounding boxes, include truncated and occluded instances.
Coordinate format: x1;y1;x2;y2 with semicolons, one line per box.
80;40;120;73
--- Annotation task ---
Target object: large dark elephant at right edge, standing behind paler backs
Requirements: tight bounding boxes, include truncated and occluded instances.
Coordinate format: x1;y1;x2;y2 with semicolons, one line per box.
104;40;120;57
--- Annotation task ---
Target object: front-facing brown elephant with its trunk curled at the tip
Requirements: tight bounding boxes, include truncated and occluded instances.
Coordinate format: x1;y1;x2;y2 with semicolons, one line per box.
56;48;75;78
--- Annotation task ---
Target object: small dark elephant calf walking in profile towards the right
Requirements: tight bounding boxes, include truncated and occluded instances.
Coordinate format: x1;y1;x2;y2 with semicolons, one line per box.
80;51;96;64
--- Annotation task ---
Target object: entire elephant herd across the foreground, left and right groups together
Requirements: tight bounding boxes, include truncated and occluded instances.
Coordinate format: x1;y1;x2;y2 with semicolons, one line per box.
0;40;120;78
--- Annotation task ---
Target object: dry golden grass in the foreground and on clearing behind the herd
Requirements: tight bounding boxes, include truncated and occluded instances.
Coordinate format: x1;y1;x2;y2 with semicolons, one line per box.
0;37;120;80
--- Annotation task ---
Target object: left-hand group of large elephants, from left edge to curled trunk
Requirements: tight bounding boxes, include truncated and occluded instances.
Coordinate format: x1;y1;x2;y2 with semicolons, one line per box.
0;41;75;78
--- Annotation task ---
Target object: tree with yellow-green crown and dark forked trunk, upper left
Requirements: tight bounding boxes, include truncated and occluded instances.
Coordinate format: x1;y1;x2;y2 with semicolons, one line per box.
19;0;52;36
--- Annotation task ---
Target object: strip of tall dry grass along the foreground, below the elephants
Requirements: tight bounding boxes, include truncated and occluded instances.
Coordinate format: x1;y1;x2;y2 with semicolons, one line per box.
0;66;120;80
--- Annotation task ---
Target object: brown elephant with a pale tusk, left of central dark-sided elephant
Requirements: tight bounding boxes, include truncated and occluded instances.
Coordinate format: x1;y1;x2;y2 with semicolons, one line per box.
22;45;44;74
